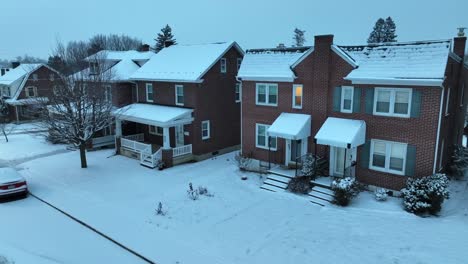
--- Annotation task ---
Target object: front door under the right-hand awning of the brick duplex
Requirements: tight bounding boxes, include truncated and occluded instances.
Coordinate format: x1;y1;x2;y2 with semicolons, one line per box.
330;147;357;177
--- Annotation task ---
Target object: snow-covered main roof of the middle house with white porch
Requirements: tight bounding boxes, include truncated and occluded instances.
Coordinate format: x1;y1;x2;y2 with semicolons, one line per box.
131;41;243;82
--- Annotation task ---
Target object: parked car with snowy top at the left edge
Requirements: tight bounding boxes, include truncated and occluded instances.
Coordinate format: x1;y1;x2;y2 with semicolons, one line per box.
0;168;28;198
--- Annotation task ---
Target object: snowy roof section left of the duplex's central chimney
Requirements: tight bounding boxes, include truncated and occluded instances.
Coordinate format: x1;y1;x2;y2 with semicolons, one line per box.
237;47;313;81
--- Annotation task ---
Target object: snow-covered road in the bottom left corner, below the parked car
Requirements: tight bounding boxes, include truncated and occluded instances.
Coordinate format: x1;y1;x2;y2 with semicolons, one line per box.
0;196;145;264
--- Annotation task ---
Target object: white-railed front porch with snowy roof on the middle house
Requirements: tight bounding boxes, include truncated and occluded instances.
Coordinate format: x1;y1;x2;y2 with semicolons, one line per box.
114;103;193;168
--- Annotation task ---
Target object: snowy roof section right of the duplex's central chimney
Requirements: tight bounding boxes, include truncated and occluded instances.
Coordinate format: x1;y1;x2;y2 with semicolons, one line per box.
337;40;450;86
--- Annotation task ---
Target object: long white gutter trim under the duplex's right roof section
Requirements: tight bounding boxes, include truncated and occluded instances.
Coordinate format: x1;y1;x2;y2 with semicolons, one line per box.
350;77;444;87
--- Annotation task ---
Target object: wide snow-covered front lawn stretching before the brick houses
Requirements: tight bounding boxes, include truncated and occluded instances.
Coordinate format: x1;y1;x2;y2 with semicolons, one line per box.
16;151;468;264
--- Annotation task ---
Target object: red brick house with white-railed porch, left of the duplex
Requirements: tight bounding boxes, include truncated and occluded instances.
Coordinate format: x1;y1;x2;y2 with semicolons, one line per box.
116;42;244;168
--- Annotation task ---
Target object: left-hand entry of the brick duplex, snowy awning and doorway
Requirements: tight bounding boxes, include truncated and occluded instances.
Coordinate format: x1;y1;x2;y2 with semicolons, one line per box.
266;113;312;168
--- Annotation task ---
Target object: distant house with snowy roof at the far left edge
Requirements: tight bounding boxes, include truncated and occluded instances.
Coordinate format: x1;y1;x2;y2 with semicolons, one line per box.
0;63;59;122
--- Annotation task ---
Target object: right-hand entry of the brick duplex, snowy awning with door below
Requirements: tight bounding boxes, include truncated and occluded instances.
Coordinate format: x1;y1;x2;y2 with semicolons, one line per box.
314;117;366;177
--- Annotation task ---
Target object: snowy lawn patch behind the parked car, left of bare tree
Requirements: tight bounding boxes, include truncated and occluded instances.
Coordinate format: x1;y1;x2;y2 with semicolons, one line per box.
0;133;66;164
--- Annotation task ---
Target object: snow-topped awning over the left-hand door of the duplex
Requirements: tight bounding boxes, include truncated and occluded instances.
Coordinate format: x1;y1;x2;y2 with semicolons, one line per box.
267;113;312;140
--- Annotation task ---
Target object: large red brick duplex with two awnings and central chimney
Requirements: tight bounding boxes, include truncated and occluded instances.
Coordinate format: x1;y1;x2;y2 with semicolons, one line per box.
238;35;466;190
